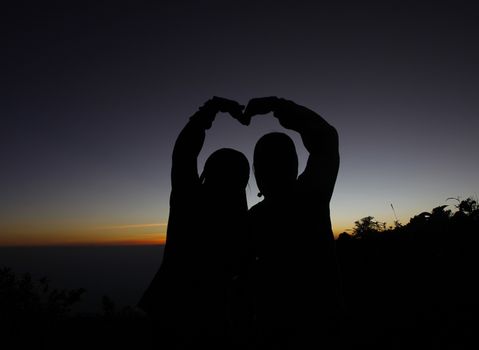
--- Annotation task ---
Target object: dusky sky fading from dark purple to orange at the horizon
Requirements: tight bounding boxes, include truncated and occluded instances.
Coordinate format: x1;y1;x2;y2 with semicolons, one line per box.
0;1;479;245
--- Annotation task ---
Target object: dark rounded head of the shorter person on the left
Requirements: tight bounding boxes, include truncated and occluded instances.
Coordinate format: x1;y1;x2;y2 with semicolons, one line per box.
200;148;249;195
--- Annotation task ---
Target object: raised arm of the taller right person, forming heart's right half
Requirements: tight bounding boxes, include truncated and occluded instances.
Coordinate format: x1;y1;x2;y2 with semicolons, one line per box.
245;97;339;199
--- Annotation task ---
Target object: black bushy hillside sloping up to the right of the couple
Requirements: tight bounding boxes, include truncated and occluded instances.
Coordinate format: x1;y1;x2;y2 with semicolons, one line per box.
337;198;479;349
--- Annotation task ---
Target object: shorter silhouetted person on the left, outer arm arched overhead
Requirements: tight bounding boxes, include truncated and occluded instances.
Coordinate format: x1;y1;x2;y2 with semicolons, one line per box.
139;97;249;349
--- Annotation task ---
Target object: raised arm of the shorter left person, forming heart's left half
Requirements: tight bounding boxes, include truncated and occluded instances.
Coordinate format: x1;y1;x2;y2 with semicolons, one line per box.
171;96;244;189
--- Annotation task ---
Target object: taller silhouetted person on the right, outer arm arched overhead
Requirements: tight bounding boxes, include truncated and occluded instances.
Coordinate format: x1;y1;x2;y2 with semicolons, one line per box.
245;97;341;349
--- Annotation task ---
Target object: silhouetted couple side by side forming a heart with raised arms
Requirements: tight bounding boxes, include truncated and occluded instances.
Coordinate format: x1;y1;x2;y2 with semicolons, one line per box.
139;97;341;349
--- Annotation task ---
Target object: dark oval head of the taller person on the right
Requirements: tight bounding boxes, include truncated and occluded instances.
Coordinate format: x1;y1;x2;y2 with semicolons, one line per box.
253;132;298;198
